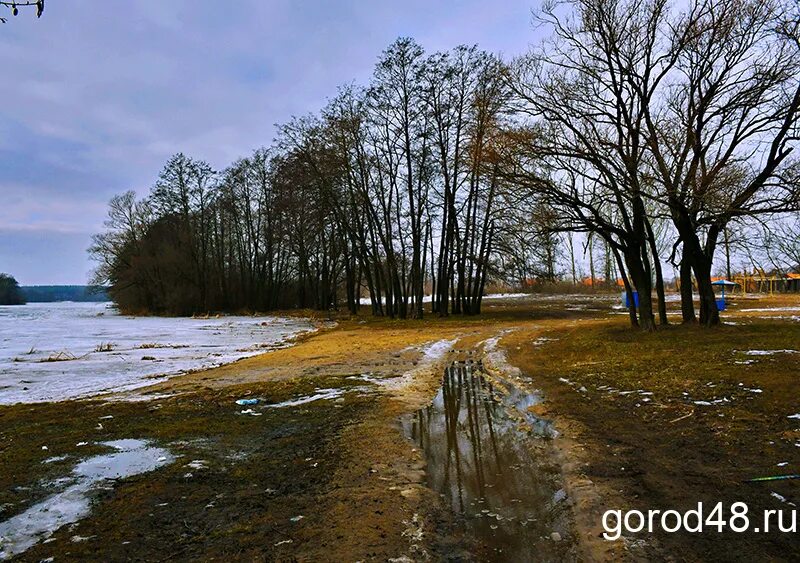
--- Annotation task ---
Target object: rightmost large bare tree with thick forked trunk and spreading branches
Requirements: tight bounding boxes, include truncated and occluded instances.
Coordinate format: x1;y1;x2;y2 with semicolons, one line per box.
644;0;800;325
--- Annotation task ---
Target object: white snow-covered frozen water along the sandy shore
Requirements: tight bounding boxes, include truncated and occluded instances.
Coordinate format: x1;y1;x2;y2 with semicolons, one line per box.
0;303;313;404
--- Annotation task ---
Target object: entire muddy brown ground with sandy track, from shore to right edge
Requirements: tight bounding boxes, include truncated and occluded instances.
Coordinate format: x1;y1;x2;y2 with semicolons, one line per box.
0;297;800;561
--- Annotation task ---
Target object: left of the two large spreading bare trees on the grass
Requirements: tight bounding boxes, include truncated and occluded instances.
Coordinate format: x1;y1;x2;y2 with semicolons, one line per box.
509;0;680;330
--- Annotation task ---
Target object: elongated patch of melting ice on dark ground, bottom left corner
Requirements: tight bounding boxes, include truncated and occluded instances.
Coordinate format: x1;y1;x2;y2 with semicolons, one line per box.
0;439;174;560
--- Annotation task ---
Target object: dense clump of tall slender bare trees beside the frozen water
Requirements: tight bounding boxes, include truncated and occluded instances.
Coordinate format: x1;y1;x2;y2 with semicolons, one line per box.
90;38;515;318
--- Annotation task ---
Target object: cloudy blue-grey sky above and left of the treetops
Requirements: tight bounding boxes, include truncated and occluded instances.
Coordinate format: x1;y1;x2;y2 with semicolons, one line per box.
0;0;537;285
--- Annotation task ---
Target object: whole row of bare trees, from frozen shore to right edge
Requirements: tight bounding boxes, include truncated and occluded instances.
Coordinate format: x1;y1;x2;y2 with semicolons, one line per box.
90;0;800;330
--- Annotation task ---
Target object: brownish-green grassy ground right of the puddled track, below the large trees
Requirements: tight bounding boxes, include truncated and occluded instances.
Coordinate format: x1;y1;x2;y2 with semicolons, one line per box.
503;315;800;560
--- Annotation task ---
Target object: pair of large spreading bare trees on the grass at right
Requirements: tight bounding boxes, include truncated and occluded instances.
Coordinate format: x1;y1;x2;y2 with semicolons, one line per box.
506;0;800;329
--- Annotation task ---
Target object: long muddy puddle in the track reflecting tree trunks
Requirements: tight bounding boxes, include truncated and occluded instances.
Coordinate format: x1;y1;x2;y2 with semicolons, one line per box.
403;363;571;561
